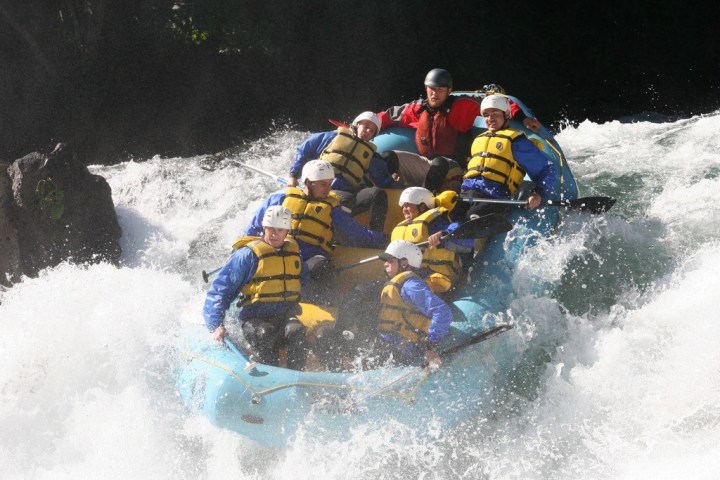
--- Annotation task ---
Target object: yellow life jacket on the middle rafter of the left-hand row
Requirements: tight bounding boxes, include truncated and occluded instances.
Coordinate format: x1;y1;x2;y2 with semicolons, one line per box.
283;187;340;253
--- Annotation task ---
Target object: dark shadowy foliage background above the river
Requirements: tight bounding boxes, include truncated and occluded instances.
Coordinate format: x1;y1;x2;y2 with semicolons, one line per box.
0;0;720;163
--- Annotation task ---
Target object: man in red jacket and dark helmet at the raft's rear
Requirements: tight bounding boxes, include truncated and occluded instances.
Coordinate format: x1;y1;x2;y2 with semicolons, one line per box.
378;68;540;193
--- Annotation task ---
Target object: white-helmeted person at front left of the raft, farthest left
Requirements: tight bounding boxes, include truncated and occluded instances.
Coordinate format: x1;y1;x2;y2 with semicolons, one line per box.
203;205;307;370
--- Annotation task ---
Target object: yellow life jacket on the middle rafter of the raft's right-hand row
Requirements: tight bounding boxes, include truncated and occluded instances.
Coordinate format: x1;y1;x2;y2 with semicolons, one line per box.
390;207;460;284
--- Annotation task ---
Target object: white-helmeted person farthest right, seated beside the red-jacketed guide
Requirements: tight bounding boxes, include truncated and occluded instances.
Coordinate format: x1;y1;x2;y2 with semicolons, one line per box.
461;95;557;218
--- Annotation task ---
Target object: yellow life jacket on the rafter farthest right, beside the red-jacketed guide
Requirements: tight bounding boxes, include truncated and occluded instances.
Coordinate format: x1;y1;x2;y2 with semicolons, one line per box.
465;128;525;195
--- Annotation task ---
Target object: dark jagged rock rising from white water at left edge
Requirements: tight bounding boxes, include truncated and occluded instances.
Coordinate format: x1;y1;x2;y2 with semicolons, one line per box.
0;144;121;285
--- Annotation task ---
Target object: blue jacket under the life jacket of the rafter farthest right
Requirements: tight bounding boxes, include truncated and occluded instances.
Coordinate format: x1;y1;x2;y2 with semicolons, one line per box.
460;137;557;198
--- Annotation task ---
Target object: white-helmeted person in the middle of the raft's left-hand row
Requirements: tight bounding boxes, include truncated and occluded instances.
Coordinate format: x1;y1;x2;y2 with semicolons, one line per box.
244;160;386;261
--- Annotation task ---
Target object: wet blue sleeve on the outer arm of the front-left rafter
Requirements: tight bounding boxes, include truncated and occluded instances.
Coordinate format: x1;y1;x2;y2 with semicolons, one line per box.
203;247;258;332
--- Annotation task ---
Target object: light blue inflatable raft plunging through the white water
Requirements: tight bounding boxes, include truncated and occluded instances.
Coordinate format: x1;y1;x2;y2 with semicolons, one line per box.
178;93;578;447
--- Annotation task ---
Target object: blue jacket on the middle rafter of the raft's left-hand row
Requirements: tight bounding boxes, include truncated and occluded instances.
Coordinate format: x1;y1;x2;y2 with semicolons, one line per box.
243;192;387;260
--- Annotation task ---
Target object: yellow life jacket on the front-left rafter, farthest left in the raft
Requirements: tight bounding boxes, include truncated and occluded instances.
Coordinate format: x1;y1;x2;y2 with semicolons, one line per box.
240;240;302;306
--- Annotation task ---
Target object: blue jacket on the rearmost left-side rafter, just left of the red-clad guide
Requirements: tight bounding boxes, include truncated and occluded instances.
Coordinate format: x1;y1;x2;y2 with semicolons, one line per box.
290;131;405;192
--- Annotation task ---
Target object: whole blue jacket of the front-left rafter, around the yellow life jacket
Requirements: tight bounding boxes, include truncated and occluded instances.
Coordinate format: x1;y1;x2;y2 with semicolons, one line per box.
203;247;308;332
